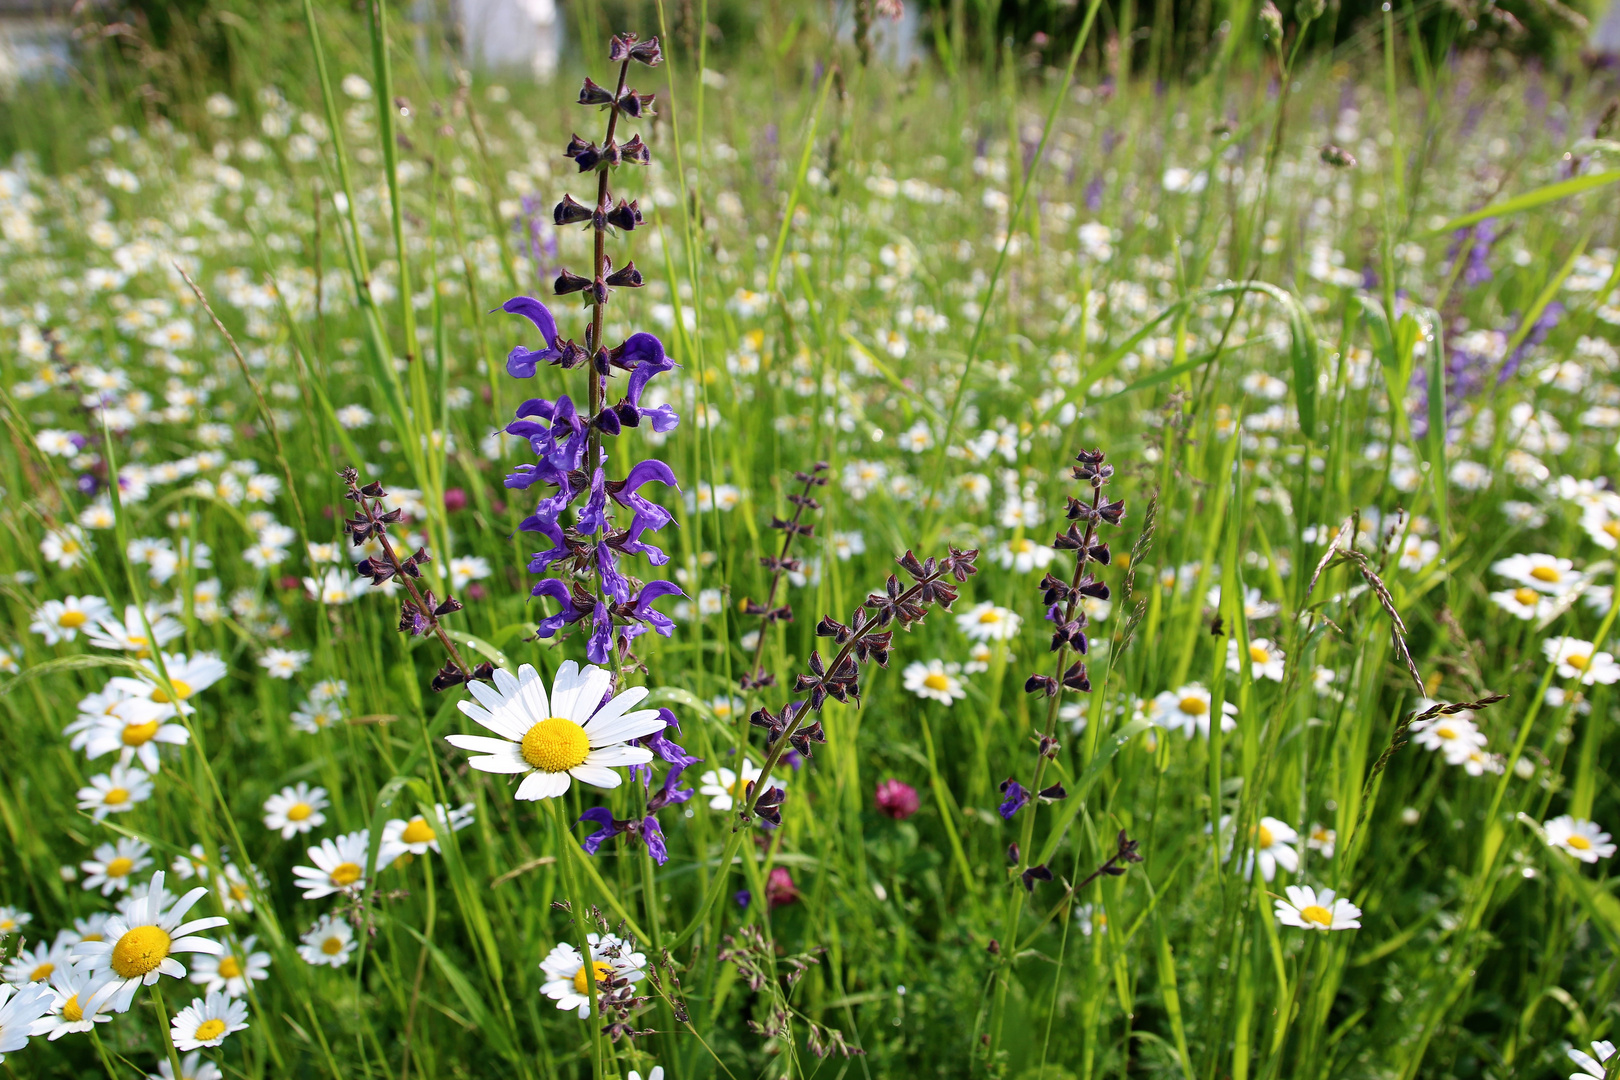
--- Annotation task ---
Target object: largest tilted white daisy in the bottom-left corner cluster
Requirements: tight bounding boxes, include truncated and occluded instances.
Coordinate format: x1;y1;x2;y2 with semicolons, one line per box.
73;871;227;1012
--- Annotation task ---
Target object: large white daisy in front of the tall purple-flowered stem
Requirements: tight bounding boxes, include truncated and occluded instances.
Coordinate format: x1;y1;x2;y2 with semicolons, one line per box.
446;661;664;800
